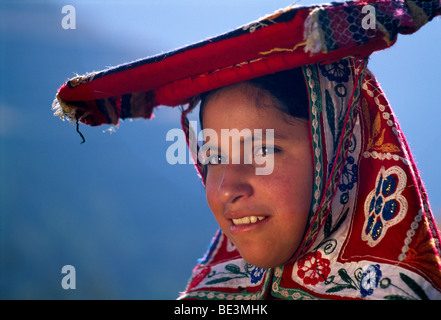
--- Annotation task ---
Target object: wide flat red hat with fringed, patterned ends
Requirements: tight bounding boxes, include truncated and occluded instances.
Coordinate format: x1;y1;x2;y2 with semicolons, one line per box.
53;1;441;126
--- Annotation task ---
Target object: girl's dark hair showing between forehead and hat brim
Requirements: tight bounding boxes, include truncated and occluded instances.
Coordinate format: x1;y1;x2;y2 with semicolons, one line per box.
199;68;309;126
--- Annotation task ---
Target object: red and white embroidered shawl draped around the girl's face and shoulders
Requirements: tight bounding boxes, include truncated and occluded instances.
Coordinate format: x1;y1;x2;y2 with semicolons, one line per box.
181;58;441;300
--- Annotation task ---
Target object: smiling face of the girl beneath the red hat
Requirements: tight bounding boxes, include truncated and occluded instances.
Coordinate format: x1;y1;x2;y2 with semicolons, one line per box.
203;83;313;268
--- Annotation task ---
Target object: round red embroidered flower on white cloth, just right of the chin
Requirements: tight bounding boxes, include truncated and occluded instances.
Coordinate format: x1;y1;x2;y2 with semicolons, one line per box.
297;251;331;286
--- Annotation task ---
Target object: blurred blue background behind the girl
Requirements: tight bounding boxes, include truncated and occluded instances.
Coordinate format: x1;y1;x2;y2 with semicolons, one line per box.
0;0;441;299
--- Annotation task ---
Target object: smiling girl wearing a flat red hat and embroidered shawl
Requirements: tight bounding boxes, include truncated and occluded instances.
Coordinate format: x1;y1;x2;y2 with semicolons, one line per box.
56;1;441;300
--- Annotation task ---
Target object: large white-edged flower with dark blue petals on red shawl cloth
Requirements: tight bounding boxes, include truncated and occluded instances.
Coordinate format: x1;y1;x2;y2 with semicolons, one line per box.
361;166;408;247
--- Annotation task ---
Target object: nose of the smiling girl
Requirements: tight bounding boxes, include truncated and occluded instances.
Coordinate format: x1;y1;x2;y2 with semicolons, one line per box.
218;164;254;204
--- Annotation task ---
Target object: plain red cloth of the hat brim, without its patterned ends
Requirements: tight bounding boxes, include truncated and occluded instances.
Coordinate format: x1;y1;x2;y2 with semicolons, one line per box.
59;8;391;106
